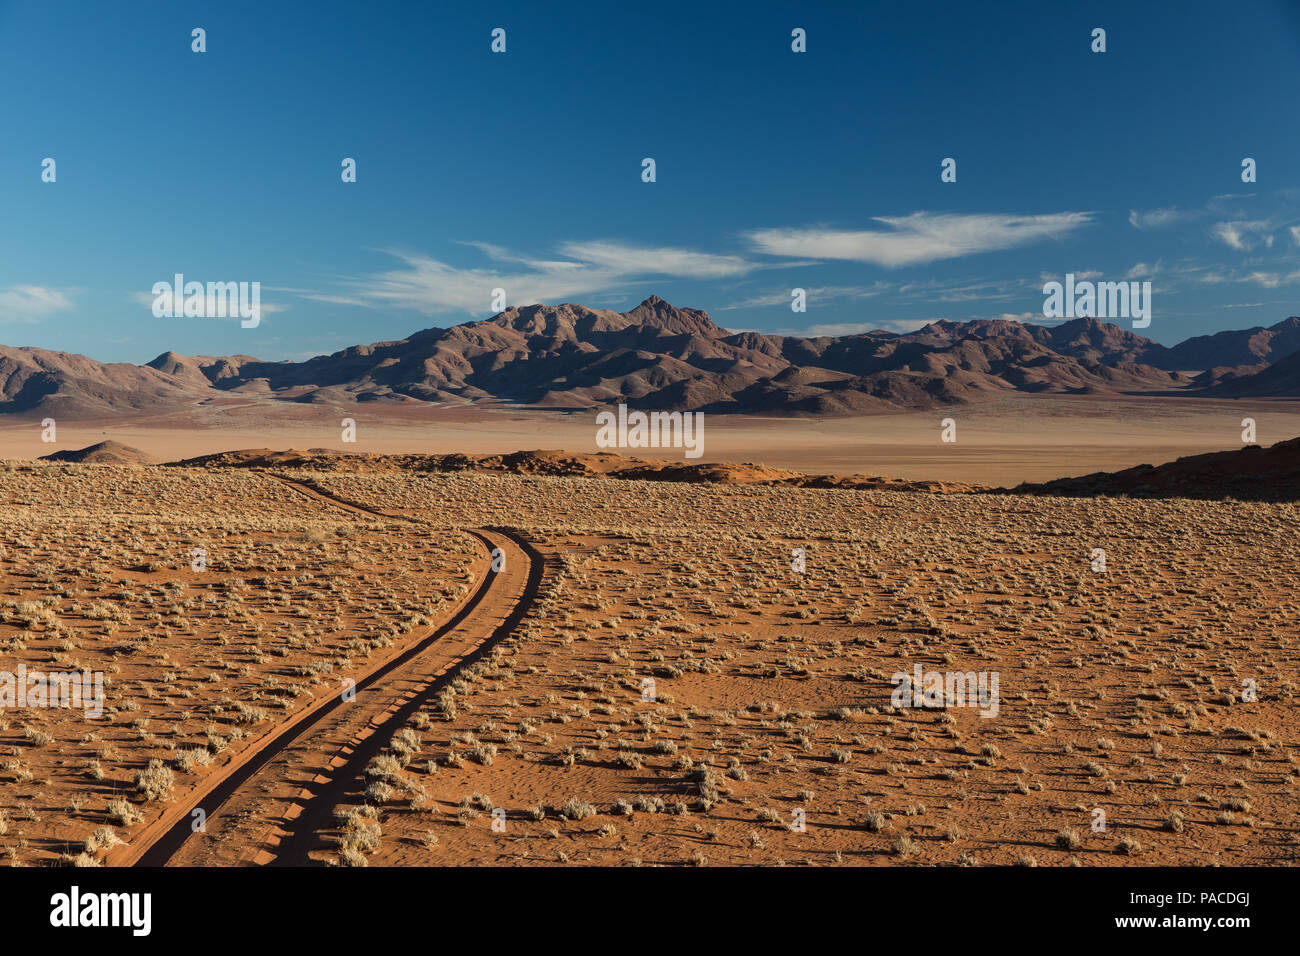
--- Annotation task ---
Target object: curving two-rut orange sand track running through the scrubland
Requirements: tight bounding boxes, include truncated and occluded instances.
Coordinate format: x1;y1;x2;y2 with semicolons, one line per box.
105;475;542;866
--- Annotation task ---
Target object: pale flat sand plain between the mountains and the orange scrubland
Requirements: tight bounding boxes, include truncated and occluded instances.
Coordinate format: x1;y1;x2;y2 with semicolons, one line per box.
0;394;1300;486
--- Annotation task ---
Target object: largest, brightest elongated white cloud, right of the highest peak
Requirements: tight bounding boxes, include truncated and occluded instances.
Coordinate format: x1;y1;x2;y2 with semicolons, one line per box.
745;212;1093;269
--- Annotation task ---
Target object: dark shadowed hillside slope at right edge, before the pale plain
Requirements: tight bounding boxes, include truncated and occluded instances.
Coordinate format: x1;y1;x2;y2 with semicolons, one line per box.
1011;438;1300;501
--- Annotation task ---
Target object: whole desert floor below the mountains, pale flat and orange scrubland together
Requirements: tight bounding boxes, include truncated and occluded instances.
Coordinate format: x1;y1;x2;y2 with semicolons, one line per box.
0;399;1300;866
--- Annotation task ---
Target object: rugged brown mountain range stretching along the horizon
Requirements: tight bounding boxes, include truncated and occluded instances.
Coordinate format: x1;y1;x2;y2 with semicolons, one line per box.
0;295;1300;418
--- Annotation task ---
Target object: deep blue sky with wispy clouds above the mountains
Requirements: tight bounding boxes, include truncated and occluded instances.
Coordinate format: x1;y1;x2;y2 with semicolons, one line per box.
0;0;1300;362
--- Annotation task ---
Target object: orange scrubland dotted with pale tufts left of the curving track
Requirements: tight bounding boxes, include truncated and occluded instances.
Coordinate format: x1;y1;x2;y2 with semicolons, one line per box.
0;466;482;865
